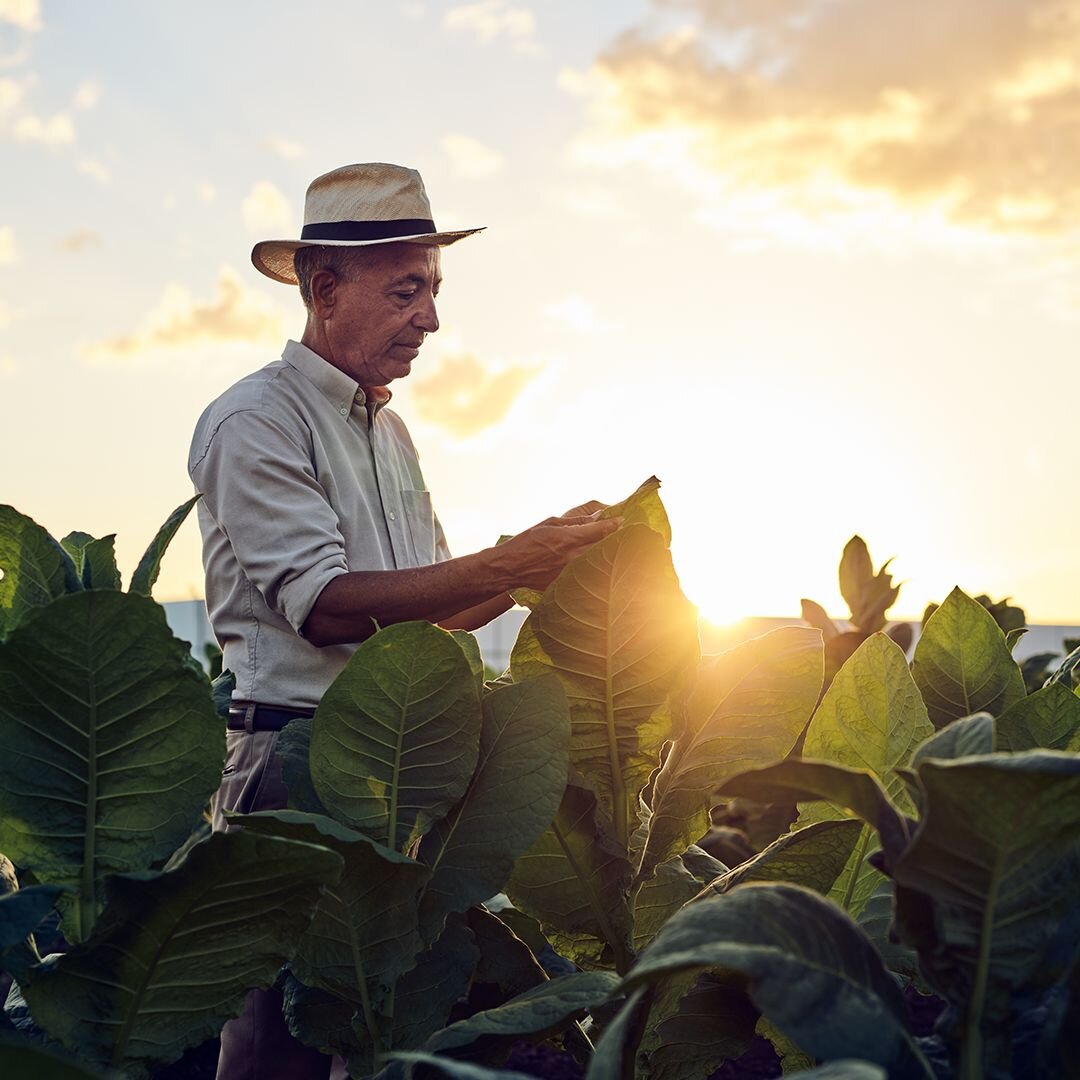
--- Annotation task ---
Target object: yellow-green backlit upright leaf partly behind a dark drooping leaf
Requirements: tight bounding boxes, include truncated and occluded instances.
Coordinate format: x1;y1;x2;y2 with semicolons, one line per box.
799;634;934;915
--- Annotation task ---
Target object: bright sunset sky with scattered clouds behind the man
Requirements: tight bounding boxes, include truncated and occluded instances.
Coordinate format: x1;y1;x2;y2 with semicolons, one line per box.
0;0;1080;624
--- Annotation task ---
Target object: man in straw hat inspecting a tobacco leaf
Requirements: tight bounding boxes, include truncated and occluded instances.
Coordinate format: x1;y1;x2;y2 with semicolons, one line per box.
189;164;618;1080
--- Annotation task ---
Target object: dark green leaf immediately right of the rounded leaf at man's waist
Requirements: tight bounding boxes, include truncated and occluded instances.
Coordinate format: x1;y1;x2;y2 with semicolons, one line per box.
417;675;570;941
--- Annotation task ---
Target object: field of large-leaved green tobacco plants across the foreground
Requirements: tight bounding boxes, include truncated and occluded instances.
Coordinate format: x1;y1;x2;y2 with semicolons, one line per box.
0;480;1080;1080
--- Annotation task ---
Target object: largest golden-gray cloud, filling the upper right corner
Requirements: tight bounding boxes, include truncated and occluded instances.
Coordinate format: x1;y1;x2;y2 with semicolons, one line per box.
579;0;1080;234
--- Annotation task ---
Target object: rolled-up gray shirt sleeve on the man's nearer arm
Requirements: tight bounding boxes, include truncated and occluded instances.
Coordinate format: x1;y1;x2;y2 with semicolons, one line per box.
190;410;349;633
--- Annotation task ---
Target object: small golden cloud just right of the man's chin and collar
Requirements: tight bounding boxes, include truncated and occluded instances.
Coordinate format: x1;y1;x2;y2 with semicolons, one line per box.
411;353;540;438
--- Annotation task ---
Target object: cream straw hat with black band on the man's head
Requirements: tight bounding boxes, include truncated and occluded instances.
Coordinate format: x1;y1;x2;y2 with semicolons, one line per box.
252;162;483;285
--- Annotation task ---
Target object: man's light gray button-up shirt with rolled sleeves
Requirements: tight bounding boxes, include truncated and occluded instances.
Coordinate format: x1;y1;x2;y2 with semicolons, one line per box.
188;341;450;708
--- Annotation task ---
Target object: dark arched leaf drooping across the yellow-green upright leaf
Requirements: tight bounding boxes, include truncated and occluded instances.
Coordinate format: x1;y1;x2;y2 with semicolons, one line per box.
719;759;913;862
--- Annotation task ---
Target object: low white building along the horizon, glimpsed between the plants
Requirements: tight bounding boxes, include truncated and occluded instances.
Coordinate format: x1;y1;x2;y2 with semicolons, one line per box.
162;600;1080;672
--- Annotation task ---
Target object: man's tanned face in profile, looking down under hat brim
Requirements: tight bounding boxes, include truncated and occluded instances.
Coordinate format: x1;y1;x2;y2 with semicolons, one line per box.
324;243;443;389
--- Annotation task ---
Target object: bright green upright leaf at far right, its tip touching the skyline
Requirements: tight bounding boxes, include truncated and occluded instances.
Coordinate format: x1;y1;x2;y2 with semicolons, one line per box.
912;589;1027;728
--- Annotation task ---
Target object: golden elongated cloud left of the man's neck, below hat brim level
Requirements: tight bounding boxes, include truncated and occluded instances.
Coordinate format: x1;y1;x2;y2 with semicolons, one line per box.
83;267;283;365
